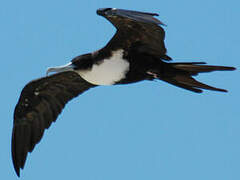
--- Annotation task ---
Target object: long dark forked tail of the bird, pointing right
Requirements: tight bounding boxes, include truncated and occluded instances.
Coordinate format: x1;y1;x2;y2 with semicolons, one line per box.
157;62;235;93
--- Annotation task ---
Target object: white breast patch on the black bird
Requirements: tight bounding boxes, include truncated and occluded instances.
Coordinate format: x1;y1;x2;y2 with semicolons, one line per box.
77;49;129;85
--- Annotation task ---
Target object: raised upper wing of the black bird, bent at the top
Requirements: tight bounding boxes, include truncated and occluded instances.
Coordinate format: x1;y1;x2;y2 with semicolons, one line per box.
97;8;171;60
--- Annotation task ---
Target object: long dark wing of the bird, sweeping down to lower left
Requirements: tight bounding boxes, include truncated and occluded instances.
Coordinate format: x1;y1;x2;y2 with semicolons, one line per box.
12;71;94;176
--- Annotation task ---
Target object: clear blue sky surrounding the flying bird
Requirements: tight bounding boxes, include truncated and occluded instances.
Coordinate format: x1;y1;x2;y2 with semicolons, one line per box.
0;0;240;180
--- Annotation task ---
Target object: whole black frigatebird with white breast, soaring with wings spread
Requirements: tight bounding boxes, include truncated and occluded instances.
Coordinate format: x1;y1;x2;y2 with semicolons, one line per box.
12;8;235;176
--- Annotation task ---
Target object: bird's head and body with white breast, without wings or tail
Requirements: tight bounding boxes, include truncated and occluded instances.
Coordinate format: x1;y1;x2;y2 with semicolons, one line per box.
58;49;153;85
